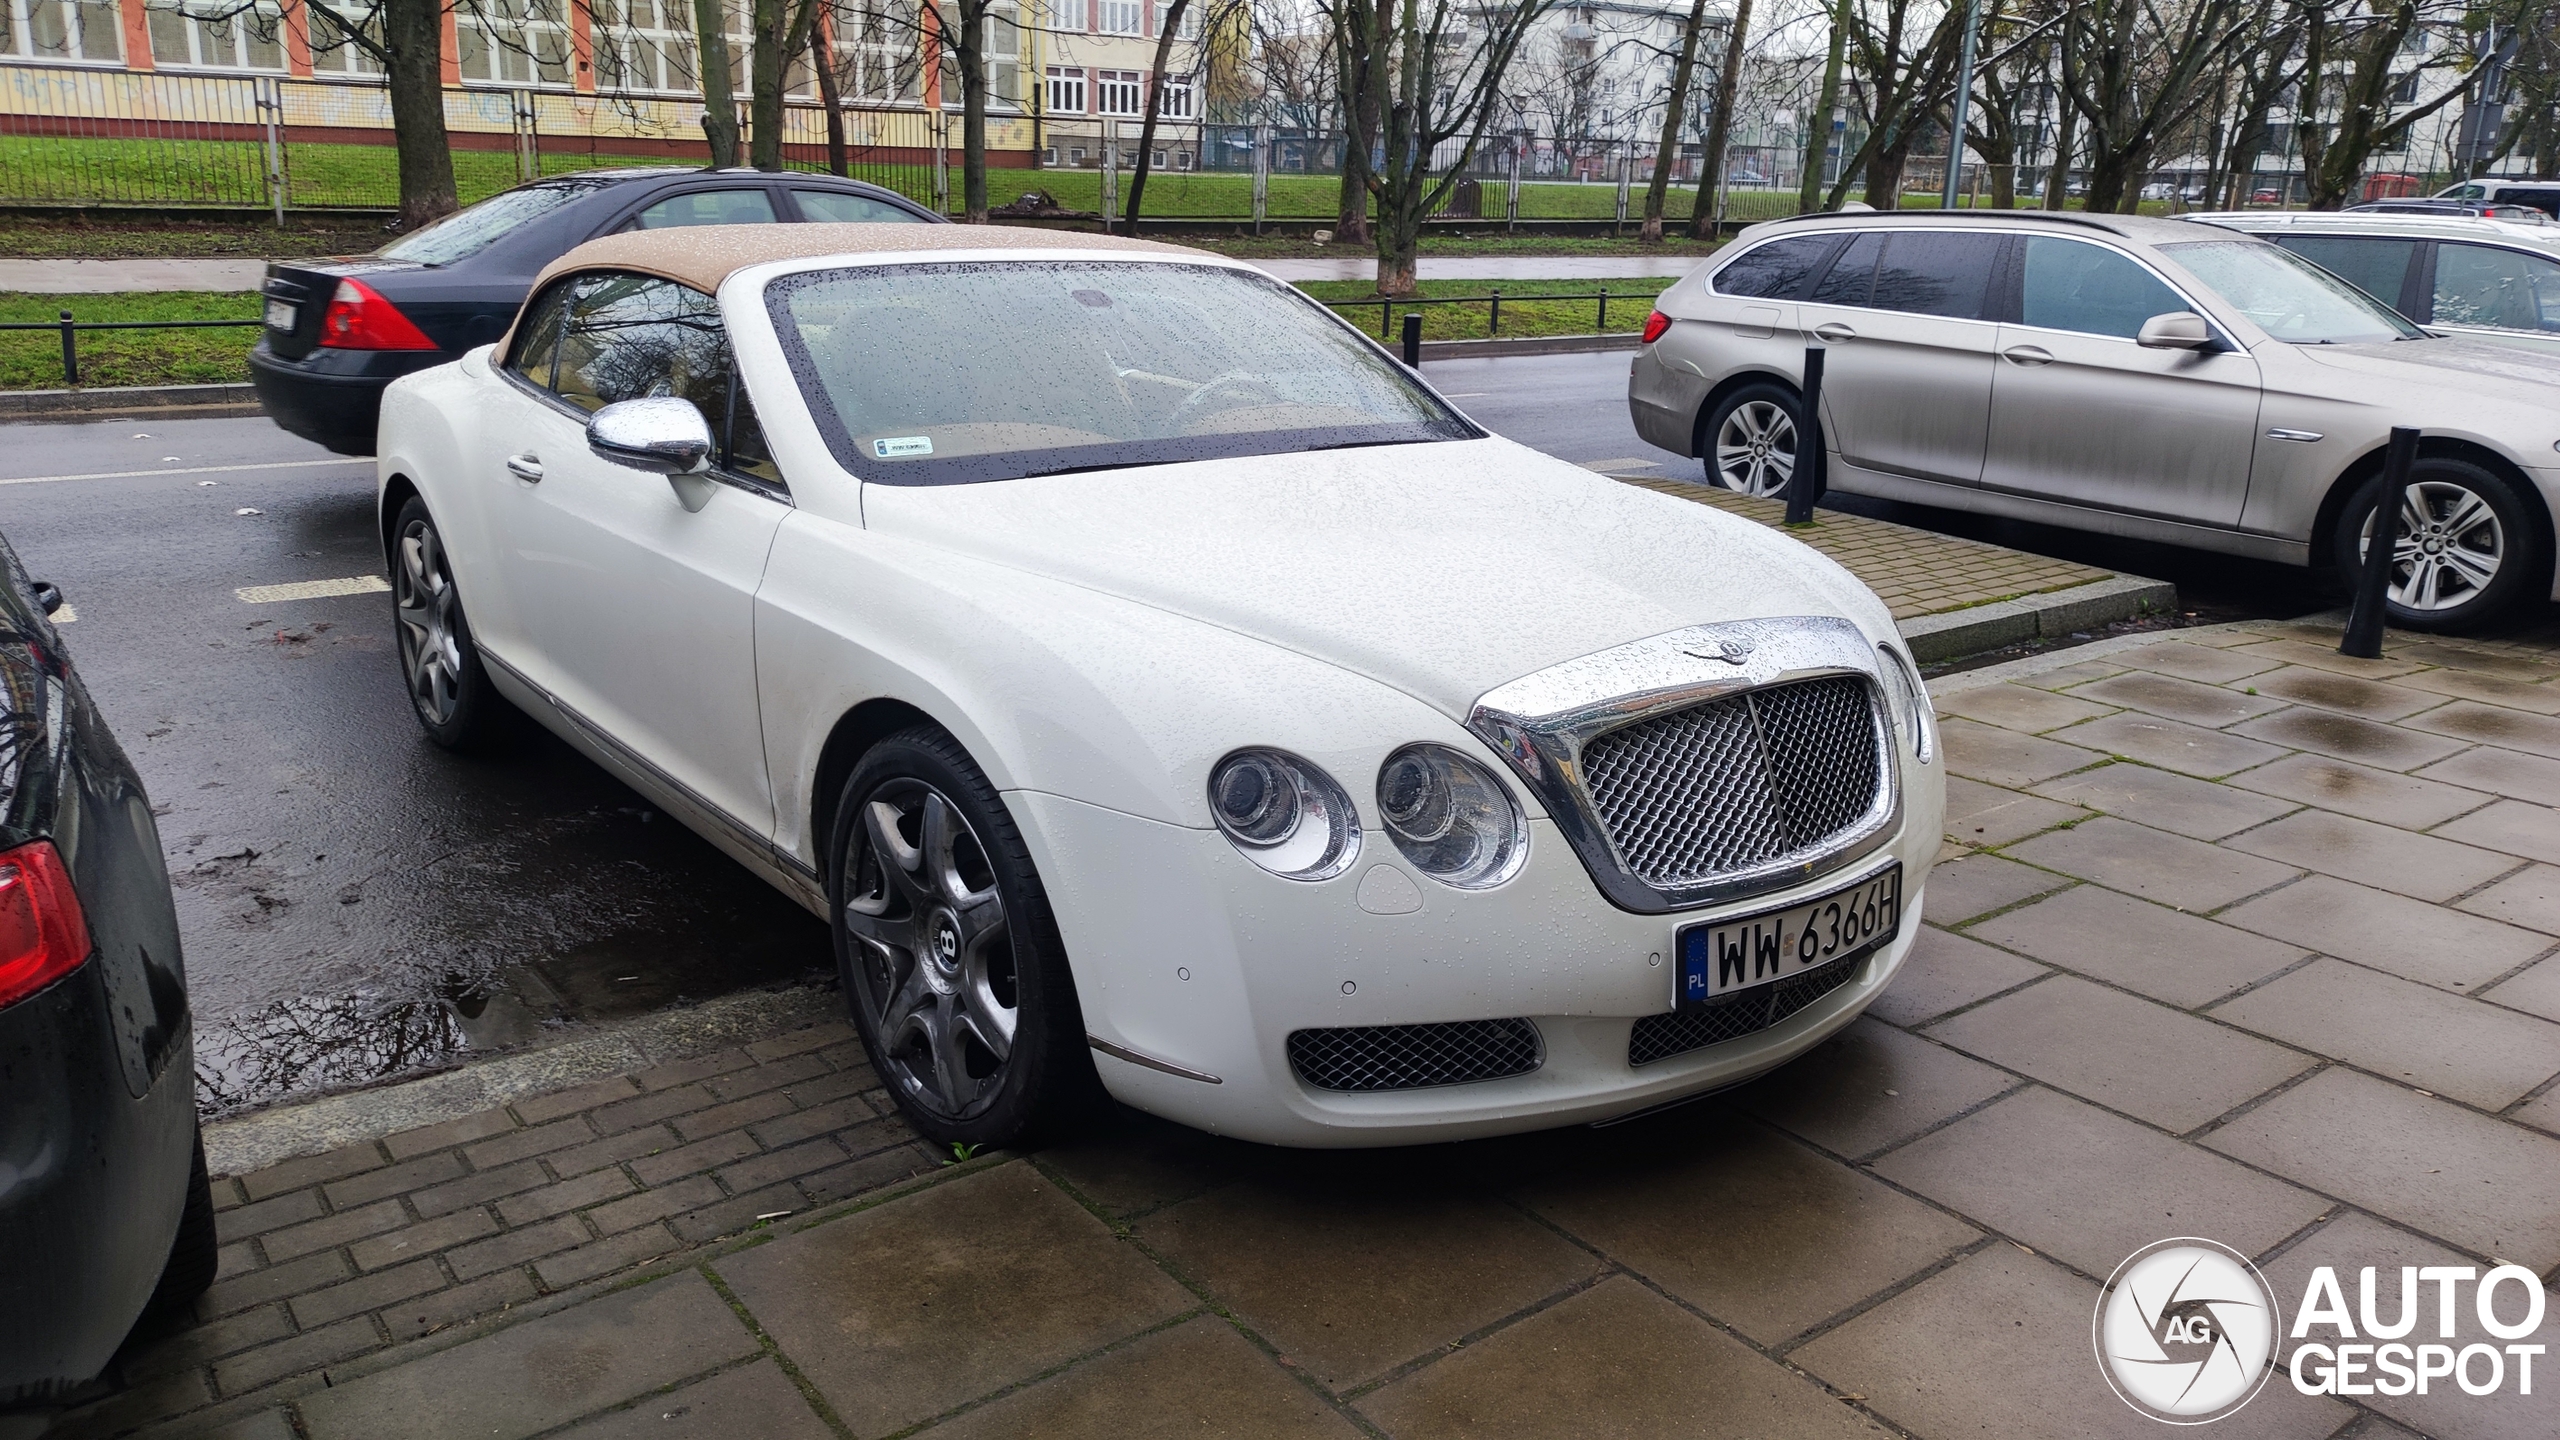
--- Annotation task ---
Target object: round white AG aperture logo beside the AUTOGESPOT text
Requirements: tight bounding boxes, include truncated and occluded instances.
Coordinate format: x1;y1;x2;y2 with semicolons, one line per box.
2092;1238;2278;1425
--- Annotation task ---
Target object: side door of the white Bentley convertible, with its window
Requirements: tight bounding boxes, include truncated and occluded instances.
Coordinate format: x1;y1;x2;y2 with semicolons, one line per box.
497;272;791;838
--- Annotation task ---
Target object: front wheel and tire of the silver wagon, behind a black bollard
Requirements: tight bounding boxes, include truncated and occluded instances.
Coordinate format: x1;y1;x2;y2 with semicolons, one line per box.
2332;456;2550;633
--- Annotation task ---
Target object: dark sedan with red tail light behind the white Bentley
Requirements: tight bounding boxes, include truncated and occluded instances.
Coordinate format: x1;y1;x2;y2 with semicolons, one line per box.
248;169;942;456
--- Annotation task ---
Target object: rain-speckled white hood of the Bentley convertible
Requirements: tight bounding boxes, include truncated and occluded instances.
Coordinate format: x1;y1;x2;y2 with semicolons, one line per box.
863;438;1892;720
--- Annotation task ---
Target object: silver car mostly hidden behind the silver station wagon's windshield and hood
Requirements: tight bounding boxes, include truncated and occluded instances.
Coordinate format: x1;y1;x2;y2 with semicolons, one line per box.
2186;210;2560;354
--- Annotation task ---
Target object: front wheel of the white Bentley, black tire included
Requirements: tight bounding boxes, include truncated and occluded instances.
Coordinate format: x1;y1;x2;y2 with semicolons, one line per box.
827;725;1101;1145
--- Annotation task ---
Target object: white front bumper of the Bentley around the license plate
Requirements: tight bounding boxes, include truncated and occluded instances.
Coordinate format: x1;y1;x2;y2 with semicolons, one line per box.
1006;784;1943;1145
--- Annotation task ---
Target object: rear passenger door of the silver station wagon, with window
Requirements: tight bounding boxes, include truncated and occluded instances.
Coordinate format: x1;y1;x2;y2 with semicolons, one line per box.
1797;231;2002;489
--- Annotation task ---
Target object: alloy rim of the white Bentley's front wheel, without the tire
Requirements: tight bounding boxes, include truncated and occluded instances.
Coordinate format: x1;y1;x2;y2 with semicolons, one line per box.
842;779;1021;1120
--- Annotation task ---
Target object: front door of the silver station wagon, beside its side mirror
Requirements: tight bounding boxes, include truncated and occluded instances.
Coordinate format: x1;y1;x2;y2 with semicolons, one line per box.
1981;236;2260;525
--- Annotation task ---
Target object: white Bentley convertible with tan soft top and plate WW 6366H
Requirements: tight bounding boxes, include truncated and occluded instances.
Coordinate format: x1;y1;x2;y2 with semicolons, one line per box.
379;225;1943;1145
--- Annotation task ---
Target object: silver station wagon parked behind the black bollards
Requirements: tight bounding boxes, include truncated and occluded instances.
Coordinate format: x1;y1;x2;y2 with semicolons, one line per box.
1628;213;2560;630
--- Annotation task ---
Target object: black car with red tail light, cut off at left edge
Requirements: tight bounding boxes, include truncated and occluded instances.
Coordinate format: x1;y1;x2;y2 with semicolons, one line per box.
0;541;218;1435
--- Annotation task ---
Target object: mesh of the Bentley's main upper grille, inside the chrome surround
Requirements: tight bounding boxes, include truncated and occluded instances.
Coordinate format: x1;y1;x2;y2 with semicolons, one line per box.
1582;676;1884;887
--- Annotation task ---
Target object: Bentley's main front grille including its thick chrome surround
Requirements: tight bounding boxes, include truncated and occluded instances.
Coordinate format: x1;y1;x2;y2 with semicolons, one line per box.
1467;615;1902;915
